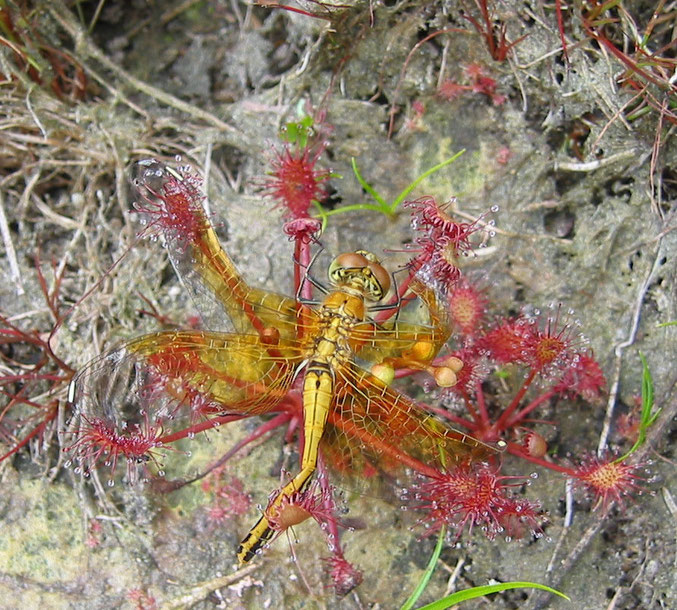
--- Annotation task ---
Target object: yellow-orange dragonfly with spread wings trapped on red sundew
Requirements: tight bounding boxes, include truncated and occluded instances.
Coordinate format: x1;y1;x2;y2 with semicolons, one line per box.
69;160;495;563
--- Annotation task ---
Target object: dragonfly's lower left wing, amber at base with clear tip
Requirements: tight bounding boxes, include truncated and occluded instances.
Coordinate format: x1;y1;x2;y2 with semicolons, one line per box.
69;331;305;472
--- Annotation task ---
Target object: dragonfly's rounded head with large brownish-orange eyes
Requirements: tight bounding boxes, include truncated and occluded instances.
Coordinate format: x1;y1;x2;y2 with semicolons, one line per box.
329;250;390;301
